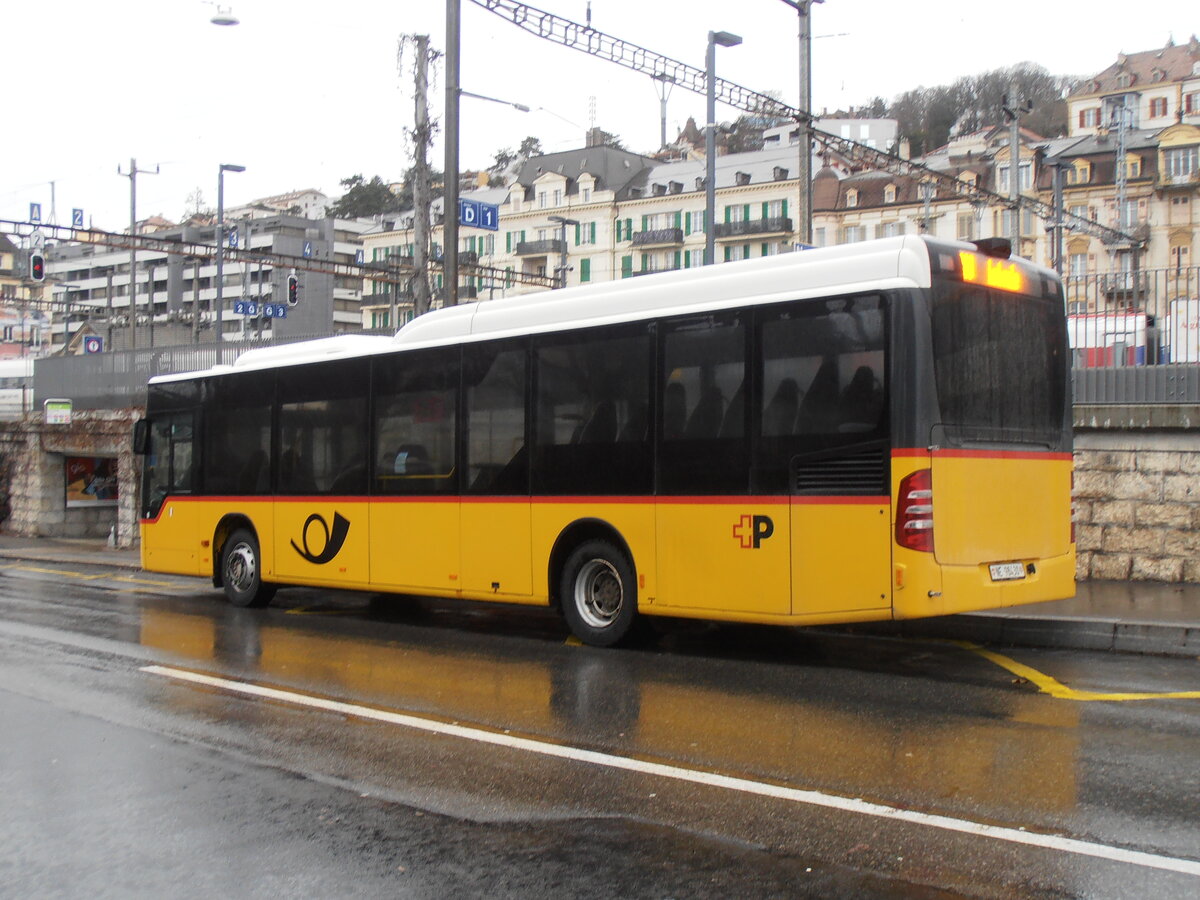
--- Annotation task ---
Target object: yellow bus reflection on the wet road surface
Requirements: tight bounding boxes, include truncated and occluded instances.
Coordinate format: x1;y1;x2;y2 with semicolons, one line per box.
140;602;1079;821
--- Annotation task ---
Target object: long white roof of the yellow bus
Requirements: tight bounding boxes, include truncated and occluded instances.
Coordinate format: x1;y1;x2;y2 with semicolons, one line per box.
150;235;936;384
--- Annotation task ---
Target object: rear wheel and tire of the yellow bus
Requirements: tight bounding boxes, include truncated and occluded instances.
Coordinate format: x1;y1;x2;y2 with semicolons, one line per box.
559;540;637;647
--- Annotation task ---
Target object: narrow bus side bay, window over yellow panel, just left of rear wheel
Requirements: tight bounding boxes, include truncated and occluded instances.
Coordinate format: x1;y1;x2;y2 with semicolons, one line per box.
460;341;533;599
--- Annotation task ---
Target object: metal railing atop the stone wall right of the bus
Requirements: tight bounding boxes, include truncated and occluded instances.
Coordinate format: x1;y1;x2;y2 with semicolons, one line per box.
1063;260;1200;404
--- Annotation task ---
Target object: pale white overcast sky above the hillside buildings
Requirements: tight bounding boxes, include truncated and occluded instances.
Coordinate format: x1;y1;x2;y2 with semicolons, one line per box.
0;0;1200;230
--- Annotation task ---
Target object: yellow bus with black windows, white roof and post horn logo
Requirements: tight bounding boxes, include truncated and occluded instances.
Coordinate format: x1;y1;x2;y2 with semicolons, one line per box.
136;236;1075;646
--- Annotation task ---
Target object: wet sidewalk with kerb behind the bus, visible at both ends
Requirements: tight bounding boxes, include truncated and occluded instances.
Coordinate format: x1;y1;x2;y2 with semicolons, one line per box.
0;535;1200;656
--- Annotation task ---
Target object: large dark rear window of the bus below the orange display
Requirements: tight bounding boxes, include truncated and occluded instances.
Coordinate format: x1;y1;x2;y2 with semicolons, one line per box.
932;282;1067;444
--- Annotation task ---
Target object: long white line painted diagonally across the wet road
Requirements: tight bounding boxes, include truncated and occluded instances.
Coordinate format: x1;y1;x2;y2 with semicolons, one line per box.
140;666;1200;877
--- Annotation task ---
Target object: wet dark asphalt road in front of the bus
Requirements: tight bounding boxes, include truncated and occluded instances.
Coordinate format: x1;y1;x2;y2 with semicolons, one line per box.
0;560;1200;898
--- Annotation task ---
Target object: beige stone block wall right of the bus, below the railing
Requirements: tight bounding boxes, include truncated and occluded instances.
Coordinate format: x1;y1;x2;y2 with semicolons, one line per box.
1075;431;1200;582
